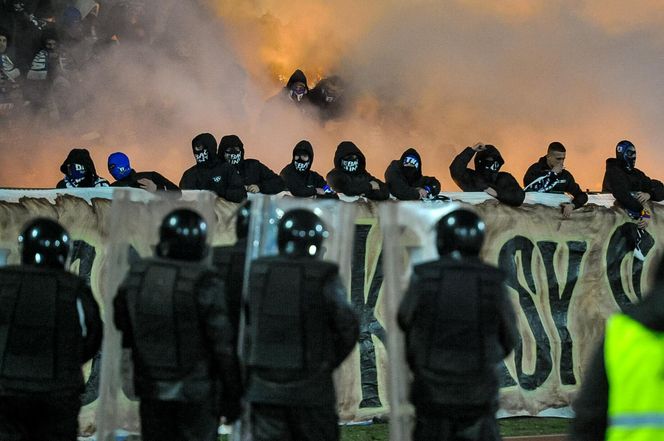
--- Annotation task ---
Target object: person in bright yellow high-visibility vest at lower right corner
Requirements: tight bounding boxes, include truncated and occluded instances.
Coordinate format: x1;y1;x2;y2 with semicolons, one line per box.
571;260;664;441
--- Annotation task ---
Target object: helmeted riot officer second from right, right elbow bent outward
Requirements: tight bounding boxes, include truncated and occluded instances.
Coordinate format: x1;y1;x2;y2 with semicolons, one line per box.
244;209;359;441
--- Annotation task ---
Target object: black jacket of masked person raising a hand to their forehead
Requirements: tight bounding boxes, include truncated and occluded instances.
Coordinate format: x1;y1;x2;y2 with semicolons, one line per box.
450;147;526;207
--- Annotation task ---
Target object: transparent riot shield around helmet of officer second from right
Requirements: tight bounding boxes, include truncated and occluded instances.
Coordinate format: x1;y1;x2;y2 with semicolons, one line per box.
232;195;355;440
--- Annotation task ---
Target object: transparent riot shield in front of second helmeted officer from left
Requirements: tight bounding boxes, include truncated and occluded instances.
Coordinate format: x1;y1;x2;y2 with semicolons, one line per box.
96;188;217;441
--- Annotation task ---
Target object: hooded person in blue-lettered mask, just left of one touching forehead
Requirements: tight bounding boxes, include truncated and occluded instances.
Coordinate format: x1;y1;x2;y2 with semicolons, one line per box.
385;148;440;201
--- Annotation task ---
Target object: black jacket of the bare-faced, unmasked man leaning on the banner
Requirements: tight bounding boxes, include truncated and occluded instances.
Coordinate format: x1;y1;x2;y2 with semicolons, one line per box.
523;156;588;208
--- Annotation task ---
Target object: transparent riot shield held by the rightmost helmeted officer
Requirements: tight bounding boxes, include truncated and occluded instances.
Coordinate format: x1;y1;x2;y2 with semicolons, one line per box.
379;202;460;441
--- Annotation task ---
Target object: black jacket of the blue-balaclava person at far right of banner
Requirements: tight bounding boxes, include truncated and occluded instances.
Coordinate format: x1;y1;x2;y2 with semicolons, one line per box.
602;158;664;213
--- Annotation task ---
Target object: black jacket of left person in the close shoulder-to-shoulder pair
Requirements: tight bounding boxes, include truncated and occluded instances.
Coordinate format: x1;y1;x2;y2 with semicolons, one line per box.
180;161;247;202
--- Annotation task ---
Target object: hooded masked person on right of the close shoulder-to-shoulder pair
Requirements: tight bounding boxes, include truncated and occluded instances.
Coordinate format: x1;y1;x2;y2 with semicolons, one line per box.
218;135;285;194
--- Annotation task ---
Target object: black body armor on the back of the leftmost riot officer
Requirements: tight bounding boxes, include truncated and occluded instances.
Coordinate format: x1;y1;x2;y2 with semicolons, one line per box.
0;267;87;392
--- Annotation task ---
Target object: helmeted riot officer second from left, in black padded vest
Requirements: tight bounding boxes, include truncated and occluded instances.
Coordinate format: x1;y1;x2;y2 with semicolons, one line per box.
114;209;241;441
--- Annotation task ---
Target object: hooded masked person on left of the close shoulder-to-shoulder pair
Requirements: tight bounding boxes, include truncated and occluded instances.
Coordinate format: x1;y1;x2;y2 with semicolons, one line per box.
180;133;247;202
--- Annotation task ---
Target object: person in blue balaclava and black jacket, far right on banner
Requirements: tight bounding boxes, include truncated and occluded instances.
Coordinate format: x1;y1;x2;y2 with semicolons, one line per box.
602;140;664;218
